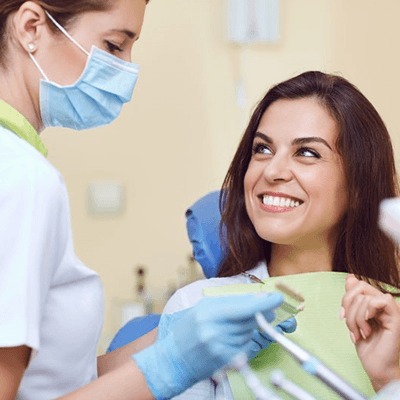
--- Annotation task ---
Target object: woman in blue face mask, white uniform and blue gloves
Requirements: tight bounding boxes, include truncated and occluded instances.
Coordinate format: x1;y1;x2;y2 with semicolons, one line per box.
0;0;290;400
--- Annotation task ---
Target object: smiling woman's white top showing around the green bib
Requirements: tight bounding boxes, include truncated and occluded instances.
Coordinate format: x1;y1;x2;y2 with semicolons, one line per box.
163;262;269;400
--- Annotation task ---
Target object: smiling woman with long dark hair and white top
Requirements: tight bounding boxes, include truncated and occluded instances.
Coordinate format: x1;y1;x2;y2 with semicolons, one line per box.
164;72;400;399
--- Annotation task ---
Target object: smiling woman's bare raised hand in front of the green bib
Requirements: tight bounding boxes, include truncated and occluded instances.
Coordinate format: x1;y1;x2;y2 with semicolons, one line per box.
340;275;400;391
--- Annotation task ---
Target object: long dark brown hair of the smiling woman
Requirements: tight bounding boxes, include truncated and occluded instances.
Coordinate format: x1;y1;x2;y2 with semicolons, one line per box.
217;71;400;291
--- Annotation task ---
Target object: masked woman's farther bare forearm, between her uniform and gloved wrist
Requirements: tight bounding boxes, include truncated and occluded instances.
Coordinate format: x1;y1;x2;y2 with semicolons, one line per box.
97;328;158;377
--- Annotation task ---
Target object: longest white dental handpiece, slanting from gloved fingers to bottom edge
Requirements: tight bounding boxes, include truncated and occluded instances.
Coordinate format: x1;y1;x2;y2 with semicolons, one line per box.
256;313;367;400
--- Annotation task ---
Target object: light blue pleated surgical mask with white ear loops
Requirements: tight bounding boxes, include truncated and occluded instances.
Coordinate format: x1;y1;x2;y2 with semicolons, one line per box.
29;13;139;130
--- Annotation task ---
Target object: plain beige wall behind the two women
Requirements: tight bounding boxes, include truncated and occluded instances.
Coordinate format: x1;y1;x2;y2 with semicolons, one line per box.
43;0;400;348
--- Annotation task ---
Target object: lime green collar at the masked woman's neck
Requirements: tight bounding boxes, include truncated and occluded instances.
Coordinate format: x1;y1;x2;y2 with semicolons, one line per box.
0;100;47;157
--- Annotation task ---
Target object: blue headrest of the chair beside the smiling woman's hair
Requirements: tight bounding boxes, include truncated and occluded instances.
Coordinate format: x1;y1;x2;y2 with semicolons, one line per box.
186;190;224;278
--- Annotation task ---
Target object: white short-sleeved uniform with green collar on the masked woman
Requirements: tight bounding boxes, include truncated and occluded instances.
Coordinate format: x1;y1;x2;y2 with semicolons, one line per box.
0;101;104;400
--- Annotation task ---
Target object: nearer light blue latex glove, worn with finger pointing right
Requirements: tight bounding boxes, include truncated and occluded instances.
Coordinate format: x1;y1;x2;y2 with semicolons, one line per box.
132;293;283;400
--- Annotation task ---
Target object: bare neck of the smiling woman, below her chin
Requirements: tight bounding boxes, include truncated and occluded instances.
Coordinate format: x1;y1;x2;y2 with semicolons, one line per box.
268;243;333;276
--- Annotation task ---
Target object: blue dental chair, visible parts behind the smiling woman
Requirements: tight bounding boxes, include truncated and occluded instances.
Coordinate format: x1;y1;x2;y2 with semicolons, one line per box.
107;190;226;353
